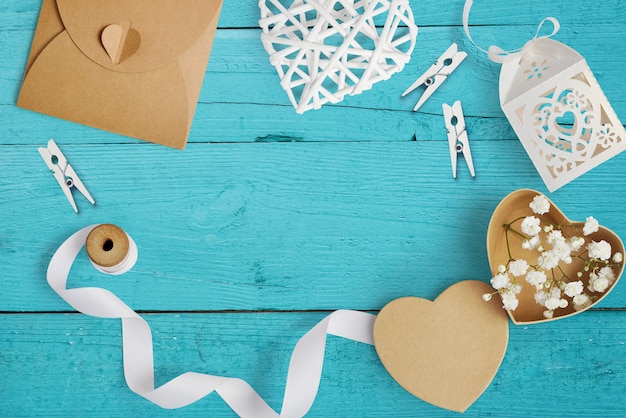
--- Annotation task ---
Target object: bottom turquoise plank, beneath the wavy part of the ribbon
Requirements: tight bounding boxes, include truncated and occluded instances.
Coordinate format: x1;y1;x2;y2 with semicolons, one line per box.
0;311;626;417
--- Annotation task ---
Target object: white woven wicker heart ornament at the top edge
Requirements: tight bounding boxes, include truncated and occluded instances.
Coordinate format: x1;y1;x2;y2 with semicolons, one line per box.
259;0;417;113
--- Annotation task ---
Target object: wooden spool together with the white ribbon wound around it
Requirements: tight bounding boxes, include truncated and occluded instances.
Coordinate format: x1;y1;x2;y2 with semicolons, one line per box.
85;224;137;275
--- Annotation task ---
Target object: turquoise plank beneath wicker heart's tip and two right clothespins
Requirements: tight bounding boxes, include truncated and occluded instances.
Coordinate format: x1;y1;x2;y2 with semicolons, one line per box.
0;25;626;145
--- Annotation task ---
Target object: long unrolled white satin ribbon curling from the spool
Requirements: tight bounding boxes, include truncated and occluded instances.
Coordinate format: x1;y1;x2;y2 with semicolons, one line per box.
47;225;376;418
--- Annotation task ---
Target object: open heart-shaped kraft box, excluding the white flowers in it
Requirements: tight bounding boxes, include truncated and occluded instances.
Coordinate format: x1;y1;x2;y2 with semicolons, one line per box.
487;189;624;325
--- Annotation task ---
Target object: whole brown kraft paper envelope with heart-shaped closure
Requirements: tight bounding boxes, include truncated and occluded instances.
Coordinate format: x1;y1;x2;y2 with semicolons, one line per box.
17;0;222;148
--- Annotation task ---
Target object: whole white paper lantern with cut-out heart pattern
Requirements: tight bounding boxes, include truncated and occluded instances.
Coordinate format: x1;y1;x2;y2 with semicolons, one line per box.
500;37;626;191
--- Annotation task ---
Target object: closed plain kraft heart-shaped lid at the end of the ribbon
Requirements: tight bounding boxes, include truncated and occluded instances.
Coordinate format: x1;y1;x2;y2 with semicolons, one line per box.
374;280;509;412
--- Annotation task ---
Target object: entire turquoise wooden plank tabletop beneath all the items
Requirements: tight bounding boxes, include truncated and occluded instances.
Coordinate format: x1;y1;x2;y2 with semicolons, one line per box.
0;0;626;417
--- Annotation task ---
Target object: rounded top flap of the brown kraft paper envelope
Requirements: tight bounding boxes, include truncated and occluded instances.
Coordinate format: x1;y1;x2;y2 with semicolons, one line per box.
57;0;221;72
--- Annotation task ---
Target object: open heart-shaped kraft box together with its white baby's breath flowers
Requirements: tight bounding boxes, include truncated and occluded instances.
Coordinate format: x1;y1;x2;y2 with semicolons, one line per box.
487;189;624;325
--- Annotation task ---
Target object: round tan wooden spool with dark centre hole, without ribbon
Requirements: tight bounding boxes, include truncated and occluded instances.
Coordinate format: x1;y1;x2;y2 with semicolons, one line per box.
86;224;130;267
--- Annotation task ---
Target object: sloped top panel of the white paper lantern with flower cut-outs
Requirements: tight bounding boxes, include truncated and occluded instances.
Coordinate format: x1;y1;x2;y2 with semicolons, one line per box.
500;37;584;105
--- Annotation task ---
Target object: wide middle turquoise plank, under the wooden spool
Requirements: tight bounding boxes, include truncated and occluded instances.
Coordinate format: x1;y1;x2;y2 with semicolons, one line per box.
0;141;626;311
